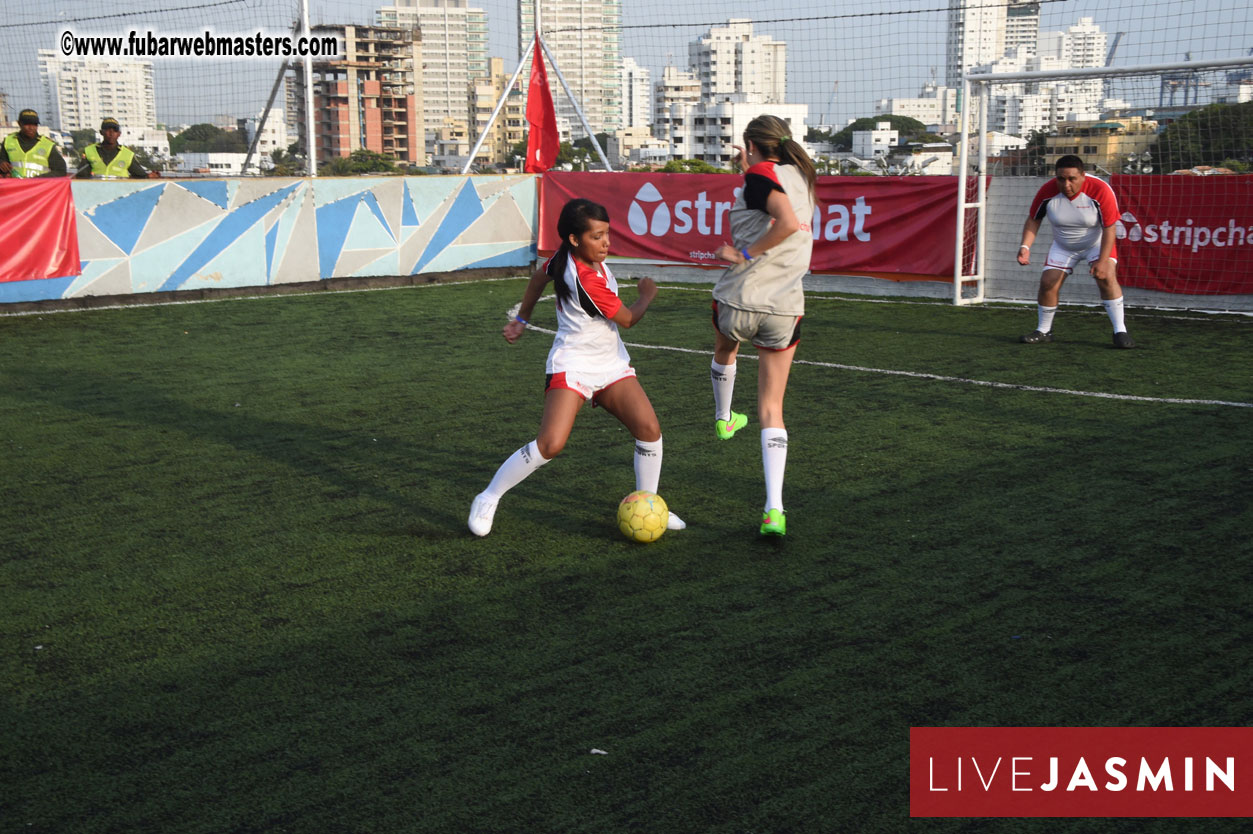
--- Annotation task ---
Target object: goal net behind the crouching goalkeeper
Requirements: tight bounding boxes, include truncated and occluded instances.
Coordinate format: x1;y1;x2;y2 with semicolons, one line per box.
966;58;1253;307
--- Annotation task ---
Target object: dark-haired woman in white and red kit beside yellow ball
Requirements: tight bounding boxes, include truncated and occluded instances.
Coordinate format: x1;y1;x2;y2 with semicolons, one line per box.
470;199;687;536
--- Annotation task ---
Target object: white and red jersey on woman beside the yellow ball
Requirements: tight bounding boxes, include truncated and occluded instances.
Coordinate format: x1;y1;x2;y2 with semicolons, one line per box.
544;254;630;373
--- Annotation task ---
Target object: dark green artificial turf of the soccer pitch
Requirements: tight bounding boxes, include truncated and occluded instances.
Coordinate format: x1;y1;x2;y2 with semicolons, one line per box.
0;281;1253;834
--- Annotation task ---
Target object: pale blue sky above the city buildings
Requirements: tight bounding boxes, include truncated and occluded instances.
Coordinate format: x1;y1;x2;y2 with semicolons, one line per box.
0;0;1253;130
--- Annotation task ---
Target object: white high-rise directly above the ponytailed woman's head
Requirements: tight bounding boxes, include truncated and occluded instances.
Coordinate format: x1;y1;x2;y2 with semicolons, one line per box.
688;19;787;104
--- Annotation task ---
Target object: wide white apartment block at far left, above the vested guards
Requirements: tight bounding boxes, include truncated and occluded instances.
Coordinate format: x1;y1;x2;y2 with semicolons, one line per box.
39;49;157;133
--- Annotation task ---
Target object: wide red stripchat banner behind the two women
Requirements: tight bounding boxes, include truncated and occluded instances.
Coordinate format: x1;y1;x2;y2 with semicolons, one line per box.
539;172;975;281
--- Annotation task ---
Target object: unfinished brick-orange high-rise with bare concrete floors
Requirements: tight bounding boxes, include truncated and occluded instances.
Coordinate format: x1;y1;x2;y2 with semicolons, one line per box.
288;24;426;165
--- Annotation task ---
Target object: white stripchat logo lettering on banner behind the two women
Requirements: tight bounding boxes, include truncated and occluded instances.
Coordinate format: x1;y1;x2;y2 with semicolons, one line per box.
627;183;873;243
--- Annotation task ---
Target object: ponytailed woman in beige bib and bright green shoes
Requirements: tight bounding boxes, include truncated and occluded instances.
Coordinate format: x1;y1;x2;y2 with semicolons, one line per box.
710;115;817;536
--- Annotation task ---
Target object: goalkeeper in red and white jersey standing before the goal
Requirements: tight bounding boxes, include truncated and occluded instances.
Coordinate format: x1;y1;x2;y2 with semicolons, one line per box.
1017;155;1135;348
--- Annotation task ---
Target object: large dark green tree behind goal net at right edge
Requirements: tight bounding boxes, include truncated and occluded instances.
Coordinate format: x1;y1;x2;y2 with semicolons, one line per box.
1153;101;1253;174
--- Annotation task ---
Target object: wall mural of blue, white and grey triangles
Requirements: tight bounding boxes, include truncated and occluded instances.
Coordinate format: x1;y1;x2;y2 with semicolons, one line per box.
0;175;538;303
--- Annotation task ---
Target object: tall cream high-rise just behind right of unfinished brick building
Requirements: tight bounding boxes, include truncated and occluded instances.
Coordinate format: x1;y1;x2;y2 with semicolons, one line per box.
375;0;490;129
